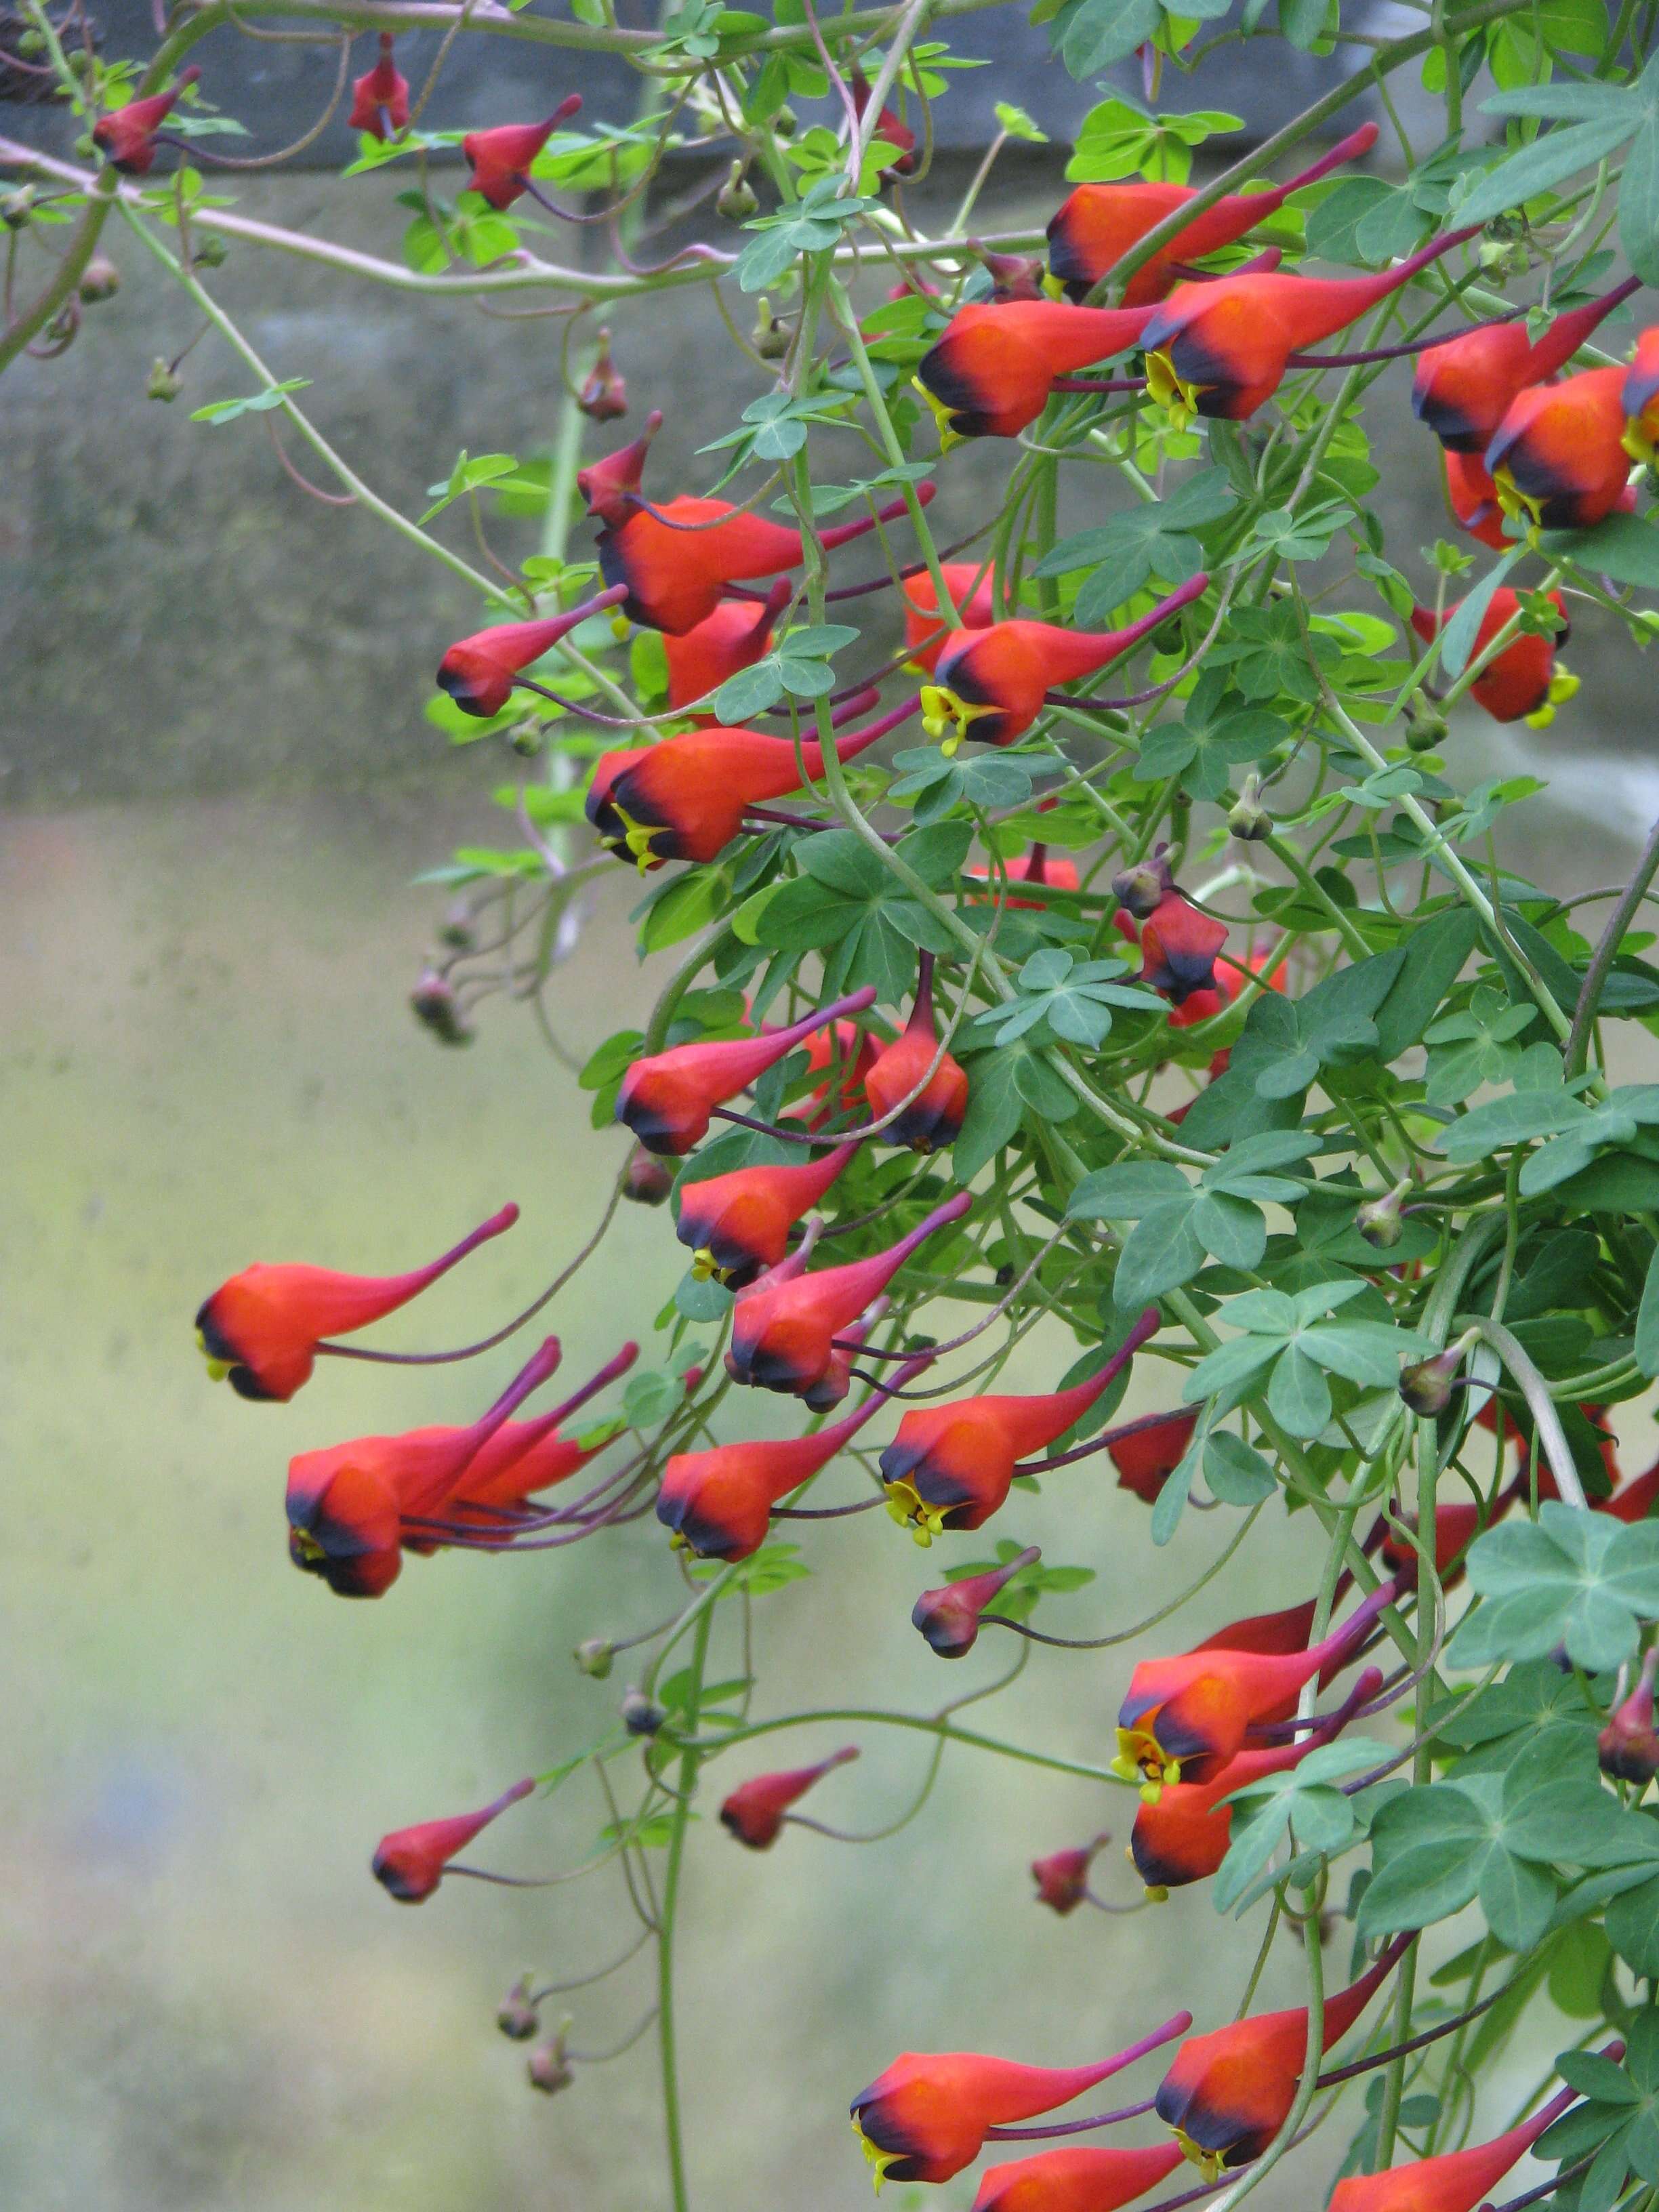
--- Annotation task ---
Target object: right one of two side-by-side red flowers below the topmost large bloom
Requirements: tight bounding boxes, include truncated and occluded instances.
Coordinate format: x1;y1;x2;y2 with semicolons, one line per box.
1141;230;1475;422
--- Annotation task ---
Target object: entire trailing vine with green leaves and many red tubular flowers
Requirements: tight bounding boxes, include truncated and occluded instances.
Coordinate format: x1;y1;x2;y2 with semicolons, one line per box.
22;0;1659;2212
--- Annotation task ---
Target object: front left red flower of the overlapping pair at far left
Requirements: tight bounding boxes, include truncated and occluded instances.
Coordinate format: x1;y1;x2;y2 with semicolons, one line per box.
287;1336;560;1597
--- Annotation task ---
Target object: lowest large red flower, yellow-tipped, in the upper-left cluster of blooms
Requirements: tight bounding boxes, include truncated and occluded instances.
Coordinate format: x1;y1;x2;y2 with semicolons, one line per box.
586;701;916;876
